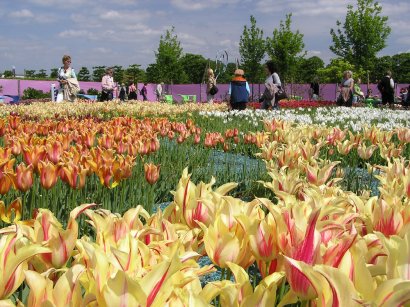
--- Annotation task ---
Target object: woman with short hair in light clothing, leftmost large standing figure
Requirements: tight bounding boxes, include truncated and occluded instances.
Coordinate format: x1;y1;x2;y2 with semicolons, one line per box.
57;55;80;102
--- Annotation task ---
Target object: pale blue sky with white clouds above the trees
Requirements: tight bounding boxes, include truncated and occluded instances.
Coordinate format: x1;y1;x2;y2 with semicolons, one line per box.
0;0;410;74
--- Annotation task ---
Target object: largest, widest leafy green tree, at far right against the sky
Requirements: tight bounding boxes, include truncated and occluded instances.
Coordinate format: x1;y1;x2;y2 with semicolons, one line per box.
330;0;391;70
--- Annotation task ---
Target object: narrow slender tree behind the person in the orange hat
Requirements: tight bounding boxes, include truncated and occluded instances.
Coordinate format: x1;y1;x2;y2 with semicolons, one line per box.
239;15;266;88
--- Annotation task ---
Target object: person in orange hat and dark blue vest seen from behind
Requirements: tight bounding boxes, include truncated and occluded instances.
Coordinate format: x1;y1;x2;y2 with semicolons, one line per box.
228;69;251;110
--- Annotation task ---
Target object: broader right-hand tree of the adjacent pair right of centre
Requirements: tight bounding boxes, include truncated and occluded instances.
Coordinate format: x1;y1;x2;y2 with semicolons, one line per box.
266;14;305;80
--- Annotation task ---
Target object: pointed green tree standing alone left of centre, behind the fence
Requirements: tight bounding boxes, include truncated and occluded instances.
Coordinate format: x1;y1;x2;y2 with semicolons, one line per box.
154;27;187;83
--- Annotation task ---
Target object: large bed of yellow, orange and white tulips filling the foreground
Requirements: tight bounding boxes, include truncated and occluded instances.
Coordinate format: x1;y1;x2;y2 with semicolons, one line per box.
0;104;410;306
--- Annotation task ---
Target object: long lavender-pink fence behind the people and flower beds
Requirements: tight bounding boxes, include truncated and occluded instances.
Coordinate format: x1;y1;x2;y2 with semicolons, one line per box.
0;79;409;102
